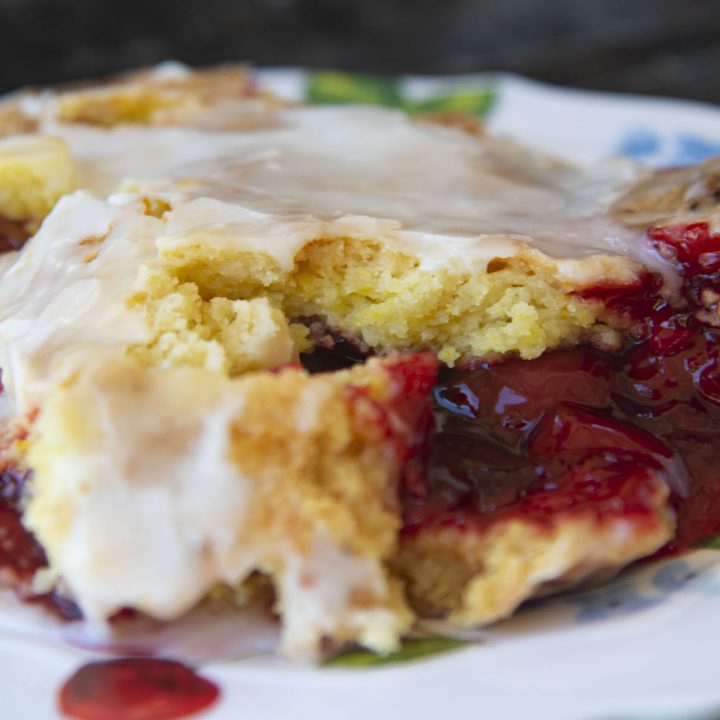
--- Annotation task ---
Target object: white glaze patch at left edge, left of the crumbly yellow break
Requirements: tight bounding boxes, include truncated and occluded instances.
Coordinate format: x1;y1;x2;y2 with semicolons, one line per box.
0;192;162;415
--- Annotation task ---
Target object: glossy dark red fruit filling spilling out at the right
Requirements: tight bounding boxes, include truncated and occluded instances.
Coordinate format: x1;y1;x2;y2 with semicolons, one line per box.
404;223;720;551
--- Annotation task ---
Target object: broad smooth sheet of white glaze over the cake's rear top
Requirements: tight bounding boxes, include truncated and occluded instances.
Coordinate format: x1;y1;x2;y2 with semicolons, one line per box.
45;107;648;270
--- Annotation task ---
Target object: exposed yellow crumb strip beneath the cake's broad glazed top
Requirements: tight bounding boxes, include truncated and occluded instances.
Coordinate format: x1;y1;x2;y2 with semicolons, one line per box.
161;233;624;365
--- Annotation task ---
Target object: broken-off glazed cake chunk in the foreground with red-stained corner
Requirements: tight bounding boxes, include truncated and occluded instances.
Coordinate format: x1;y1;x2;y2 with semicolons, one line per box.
25;355;436;656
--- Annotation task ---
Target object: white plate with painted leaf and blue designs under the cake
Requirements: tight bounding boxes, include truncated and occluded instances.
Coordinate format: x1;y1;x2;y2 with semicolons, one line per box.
0;69;720;720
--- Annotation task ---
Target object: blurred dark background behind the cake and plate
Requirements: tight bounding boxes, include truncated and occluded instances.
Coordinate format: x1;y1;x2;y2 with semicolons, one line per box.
0;0;720;103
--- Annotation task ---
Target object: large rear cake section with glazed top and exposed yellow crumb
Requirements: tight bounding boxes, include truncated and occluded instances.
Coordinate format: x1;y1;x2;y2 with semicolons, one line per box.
0;66;663;364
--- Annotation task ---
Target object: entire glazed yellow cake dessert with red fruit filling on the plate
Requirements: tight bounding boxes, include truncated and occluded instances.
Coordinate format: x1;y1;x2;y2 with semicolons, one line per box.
0;68;720;656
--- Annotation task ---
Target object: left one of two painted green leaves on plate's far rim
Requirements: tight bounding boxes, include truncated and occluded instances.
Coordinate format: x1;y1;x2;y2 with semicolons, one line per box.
306;71;403;107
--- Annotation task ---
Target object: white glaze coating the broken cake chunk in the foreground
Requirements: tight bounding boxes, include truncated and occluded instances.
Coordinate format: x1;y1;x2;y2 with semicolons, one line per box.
25;354;405;657
